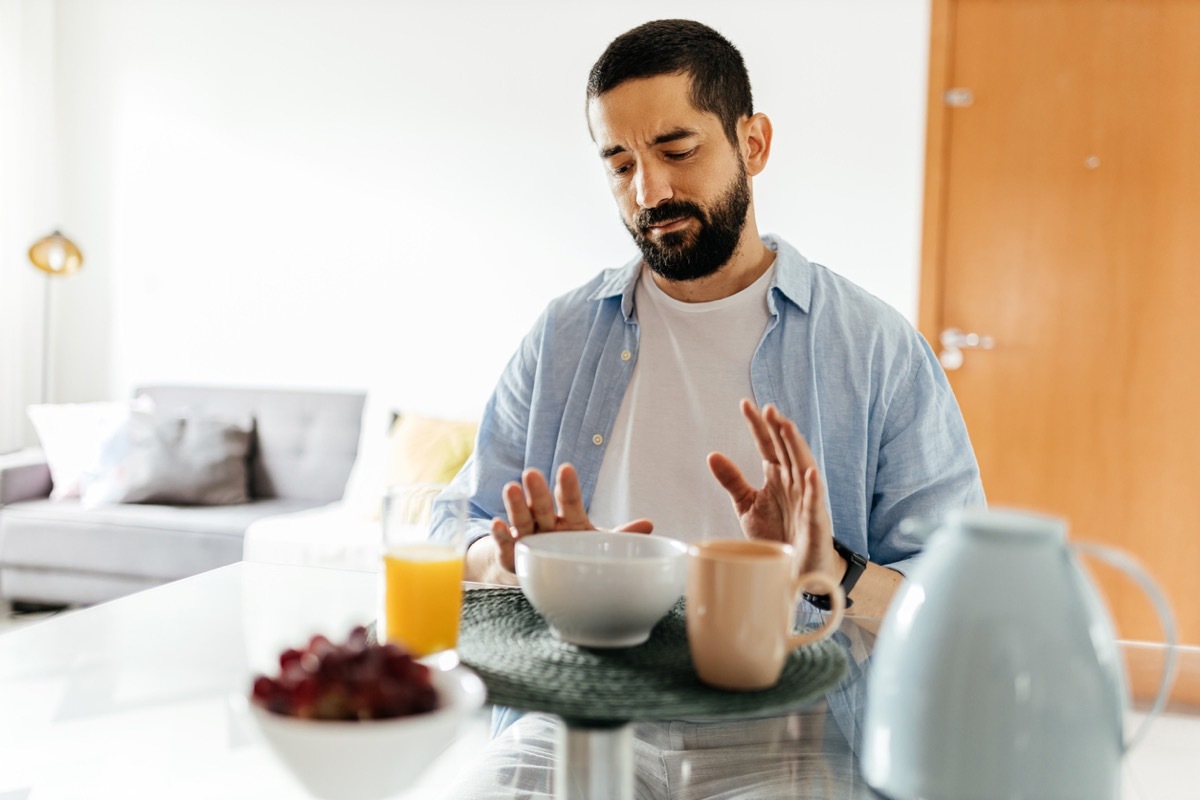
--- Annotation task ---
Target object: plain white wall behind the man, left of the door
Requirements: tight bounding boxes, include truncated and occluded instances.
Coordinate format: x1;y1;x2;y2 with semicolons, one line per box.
0;0;929;443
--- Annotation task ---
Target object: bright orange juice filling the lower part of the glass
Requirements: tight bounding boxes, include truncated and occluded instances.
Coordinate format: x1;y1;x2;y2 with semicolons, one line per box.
383;543;463;657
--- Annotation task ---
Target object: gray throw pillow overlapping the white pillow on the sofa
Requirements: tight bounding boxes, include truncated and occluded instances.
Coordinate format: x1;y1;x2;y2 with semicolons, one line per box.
80;410;253;507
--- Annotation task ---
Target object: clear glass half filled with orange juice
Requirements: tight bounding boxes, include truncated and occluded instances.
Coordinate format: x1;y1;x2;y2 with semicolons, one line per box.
382;483;467;657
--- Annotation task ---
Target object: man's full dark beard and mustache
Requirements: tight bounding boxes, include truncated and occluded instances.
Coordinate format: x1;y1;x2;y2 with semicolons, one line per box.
625;163;750;281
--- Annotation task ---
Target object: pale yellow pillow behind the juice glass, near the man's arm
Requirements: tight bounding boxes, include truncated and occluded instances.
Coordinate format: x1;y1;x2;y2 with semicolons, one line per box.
372;414;479;519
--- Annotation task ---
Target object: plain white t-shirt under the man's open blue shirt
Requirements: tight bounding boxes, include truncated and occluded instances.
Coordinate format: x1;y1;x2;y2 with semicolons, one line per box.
588;265;775;542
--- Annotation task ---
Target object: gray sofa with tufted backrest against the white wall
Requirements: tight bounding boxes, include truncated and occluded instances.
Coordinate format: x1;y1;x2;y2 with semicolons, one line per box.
0;386;365;604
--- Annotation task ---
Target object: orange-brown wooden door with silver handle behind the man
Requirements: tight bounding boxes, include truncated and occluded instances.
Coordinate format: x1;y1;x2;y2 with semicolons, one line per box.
920;0;1200;644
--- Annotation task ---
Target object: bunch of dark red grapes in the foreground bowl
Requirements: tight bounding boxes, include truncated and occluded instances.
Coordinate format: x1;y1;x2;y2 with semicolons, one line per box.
251;625;438;720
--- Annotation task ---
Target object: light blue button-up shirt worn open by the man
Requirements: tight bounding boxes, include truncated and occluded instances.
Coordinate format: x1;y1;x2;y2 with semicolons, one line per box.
433;231;984;572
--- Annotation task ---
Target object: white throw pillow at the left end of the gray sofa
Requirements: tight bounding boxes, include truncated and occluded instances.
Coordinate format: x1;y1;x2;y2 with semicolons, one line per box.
28;402;130;500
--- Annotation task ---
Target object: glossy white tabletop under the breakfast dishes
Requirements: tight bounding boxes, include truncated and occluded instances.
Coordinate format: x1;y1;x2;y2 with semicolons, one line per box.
0;563;1200;800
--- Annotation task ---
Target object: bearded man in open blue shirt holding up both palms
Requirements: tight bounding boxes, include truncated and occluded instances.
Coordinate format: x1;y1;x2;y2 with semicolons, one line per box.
434;20;984;615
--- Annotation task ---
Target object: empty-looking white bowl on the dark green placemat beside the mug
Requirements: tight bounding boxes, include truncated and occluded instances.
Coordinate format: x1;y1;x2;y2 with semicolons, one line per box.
516;530;688;648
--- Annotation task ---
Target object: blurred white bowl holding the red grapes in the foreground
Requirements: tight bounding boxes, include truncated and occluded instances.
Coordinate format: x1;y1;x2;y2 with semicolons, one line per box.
250;667;486;800
